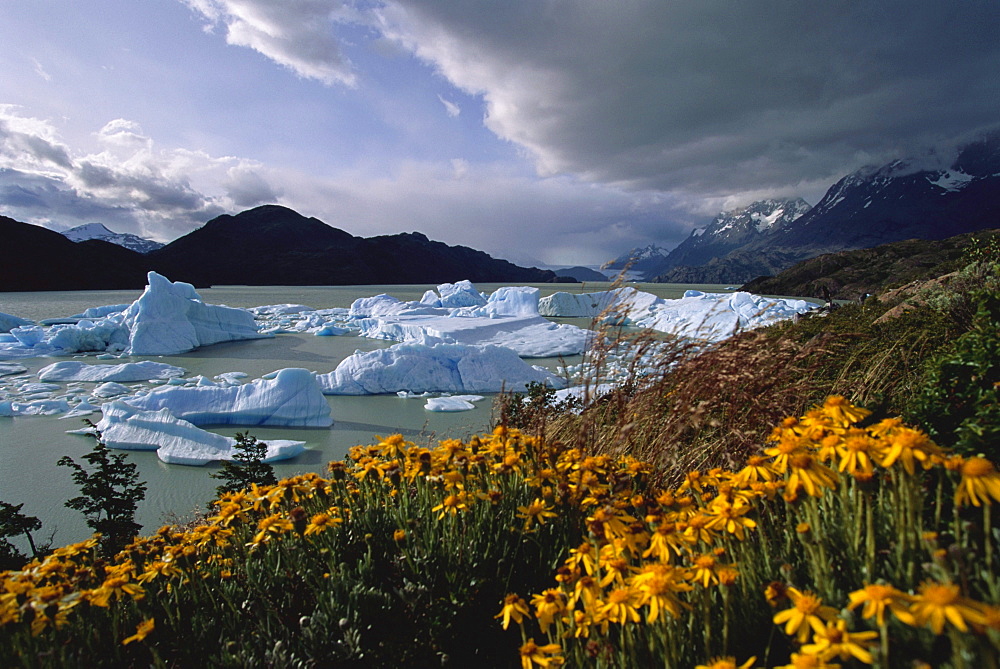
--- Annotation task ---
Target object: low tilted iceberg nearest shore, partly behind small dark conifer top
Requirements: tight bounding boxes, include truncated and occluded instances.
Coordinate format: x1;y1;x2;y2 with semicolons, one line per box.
97;401;305;465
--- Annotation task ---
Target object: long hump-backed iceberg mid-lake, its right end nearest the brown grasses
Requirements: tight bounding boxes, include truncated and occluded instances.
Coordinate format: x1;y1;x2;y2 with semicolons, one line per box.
317;340;561;395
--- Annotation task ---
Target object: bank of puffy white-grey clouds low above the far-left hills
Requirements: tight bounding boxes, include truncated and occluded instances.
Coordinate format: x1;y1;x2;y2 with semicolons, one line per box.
0;105;274;240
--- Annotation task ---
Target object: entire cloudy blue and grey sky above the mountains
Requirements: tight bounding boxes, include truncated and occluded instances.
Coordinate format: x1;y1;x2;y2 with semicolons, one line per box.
0;0;1000;265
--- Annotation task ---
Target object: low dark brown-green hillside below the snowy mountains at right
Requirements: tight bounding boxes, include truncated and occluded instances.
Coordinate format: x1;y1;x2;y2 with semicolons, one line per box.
741;229;1000;300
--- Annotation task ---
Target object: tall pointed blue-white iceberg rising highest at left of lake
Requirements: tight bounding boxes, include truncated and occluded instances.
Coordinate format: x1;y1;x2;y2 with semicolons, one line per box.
123;272;267;355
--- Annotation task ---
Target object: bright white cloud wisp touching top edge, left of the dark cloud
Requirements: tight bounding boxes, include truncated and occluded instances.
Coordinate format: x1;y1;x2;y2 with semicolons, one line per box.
183;0;355;86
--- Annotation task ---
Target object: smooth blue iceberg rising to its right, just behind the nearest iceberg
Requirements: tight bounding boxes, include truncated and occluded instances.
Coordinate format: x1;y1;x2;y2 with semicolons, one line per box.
126;368;333;427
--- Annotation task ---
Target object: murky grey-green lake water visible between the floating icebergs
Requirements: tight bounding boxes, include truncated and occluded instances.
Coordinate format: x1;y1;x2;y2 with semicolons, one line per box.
0;282;727;546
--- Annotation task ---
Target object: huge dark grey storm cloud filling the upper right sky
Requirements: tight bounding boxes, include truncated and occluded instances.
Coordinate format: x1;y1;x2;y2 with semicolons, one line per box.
384;0;1000;197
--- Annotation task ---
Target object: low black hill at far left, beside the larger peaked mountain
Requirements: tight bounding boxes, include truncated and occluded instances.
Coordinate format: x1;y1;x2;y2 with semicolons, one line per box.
0;216;148;292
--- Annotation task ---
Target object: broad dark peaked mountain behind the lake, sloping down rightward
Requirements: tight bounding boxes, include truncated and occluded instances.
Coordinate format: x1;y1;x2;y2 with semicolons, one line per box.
147;205;555;286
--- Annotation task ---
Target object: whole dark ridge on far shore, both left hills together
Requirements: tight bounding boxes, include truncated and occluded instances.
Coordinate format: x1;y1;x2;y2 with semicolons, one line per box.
0;205;555;291
